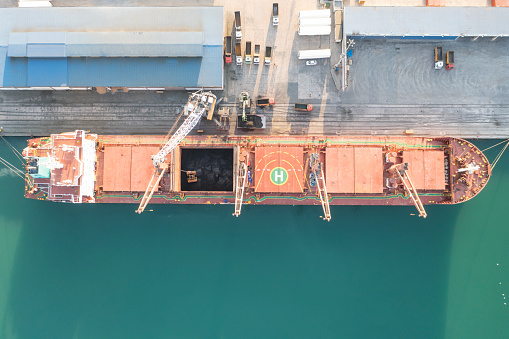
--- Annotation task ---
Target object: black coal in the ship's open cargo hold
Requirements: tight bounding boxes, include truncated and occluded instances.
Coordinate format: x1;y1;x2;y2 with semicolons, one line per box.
180;148;233;191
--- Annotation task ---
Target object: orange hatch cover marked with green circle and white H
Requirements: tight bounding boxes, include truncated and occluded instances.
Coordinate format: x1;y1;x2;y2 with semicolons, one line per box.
254;146;304;193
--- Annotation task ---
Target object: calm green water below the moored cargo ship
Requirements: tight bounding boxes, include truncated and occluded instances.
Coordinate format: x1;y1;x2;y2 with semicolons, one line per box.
0;138;509;339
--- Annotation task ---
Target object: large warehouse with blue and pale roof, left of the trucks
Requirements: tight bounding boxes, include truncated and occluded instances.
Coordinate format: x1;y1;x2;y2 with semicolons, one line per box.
0;7;223;90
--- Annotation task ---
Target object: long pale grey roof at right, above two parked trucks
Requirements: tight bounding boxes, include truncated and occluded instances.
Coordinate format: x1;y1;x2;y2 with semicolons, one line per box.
344;7;509;36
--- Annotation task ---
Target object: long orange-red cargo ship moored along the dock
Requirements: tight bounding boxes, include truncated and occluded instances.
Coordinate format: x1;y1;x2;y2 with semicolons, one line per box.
23;130;491;220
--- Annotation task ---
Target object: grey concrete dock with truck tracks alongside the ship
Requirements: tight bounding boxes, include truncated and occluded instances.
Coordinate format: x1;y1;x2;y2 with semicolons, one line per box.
0;0;509;138
